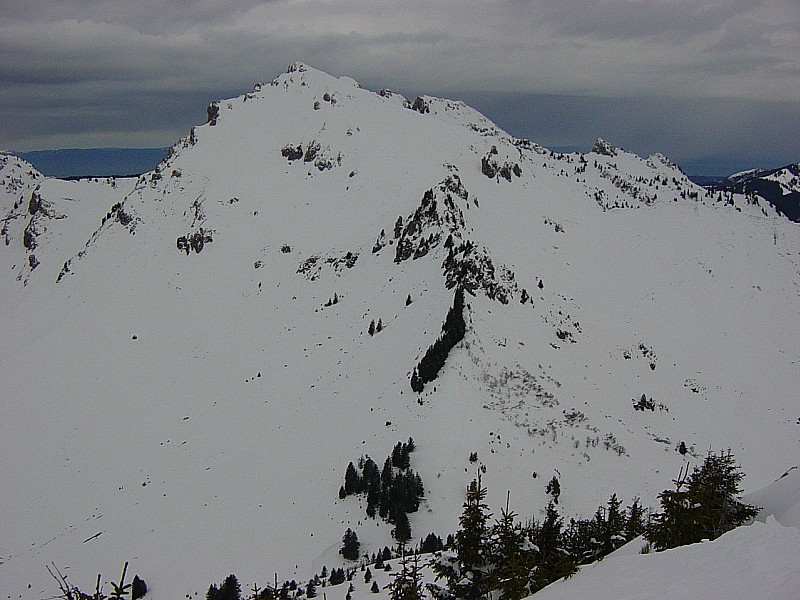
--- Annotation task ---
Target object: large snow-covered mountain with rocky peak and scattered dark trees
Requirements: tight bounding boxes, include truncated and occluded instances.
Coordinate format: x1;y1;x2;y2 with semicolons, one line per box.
0;64;800;598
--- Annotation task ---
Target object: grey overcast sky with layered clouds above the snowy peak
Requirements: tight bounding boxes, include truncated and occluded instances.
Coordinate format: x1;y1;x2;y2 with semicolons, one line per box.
0;0;800;174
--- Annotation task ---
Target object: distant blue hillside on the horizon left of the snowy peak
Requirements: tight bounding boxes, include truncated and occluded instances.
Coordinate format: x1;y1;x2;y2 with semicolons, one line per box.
18;148;167;179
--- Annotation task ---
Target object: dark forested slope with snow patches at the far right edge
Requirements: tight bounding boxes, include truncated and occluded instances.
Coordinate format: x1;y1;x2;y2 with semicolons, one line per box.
704;163;800;223
